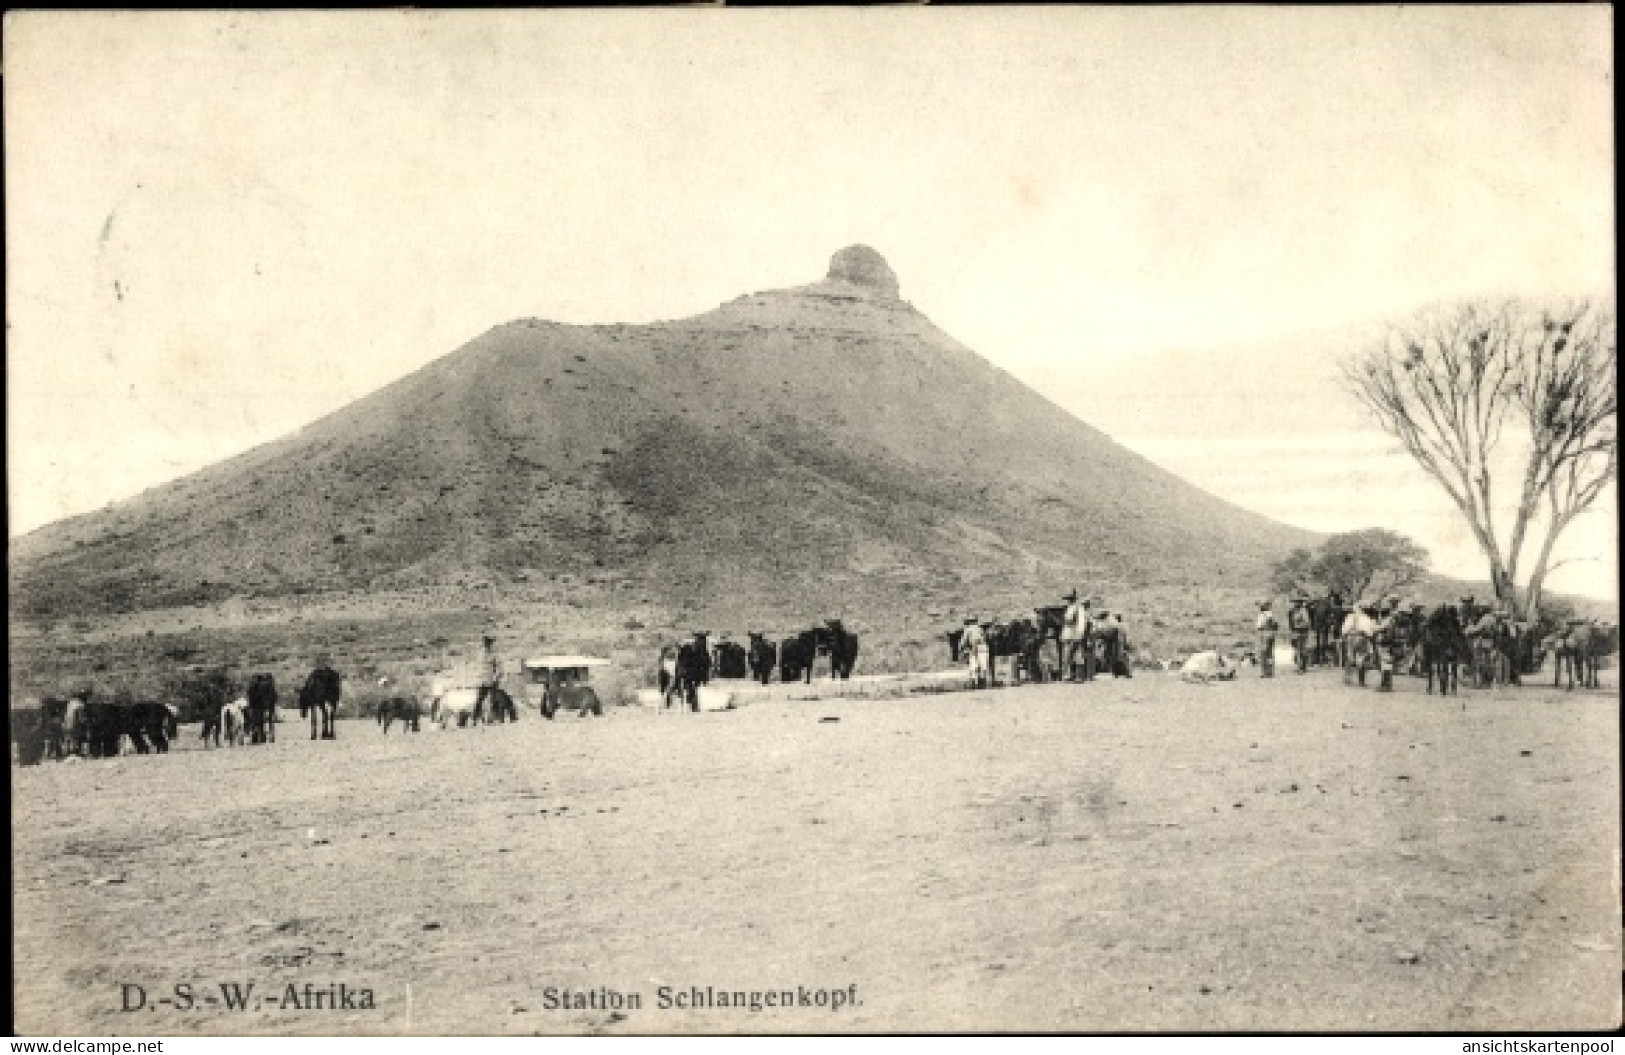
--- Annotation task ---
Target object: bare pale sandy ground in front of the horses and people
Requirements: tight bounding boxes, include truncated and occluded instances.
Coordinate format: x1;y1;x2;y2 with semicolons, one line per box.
13;671;1620;1035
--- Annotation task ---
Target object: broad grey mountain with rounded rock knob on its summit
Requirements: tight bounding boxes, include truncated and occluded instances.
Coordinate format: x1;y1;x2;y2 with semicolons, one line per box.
11;247;1310;618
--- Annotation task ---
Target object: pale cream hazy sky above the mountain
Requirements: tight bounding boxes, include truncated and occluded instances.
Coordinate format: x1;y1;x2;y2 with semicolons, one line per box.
3;5;1617;598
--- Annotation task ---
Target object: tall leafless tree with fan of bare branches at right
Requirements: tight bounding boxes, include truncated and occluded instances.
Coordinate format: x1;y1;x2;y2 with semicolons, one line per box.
1344;301;1619;618
